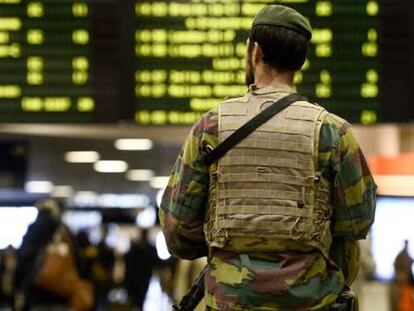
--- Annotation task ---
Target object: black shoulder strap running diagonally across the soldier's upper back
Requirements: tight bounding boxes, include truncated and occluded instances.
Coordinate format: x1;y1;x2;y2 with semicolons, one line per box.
205;93;303;166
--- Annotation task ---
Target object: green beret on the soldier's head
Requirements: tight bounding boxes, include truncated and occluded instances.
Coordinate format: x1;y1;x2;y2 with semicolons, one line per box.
253;4;312;40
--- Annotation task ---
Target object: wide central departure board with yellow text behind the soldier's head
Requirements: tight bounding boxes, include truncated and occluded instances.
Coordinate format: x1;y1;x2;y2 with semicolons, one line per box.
135;0;381;125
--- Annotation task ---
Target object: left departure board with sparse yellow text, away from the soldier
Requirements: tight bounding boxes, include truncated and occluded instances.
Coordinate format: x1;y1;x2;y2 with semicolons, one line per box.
0;0;121;122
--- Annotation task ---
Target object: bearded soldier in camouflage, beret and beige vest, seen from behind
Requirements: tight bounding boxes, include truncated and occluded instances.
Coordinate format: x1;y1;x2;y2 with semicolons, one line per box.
159;5;376;310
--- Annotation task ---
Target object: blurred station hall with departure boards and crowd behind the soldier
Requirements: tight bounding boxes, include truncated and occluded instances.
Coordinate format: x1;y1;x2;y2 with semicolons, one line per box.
0;0;414;311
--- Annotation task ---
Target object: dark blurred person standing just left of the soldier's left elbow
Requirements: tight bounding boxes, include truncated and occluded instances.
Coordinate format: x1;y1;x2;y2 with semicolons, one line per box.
124;229;158;310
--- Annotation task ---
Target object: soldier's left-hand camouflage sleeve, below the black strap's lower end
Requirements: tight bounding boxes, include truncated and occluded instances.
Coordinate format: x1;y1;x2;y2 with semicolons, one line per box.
158;113;217;259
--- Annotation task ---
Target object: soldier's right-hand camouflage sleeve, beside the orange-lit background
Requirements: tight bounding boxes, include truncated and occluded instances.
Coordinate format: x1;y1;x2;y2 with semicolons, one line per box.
319;114;376;285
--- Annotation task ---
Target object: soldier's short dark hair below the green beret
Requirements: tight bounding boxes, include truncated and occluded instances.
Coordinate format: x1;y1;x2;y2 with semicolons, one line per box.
248;25;309;72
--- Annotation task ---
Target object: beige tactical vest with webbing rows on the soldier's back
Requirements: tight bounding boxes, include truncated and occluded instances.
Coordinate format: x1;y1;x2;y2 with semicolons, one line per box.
205;93;332;255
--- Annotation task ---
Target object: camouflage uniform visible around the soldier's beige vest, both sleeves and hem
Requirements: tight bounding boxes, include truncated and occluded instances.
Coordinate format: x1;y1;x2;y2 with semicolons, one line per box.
159;86;376;310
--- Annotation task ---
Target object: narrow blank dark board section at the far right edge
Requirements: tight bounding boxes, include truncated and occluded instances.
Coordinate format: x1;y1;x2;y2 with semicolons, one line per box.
379;0;414;123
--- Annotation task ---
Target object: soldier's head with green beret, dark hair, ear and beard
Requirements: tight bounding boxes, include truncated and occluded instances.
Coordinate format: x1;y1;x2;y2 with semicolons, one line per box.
246;5;312;85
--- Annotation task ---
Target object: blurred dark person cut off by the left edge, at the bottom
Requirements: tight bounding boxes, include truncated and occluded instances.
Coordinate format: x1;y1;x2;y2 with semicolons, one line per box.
0;245;17;308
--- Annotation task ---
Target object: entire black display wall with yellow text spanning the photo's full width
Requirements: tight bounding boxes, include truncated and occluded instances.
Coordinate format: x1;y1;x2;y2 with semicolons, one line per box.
0;0;414;125
